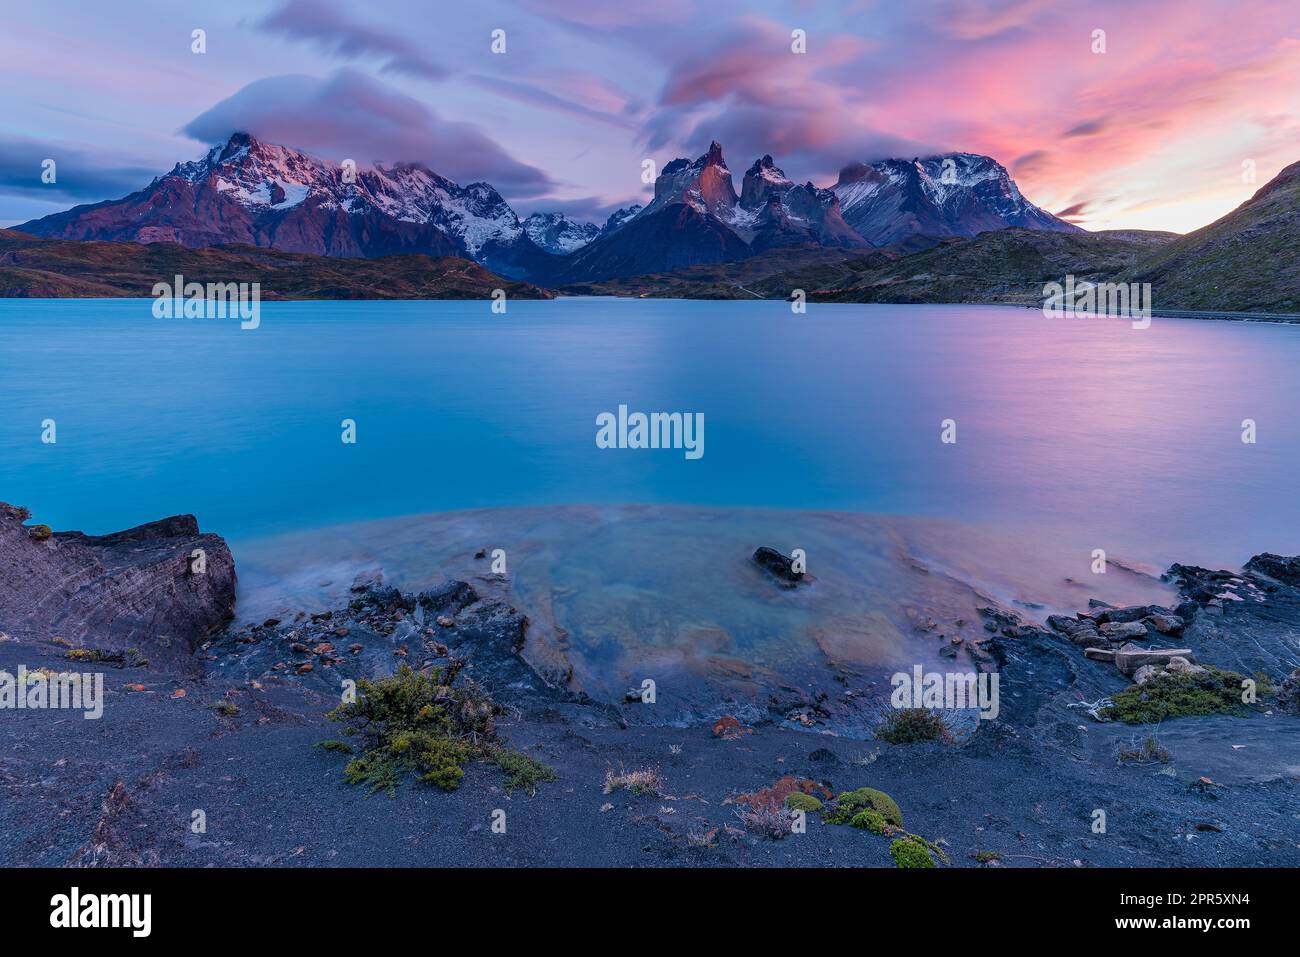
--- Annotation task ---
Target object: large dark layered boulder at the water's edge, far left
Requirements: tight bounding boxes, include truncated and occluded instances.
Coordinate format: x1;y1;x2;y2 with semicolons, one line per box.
0;503;235;667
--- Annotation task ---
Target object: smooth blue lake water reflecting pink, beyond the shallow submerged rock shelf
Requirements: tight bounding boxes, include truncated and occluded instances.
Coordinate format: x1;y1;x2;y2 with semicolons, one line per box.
0;299;1300;566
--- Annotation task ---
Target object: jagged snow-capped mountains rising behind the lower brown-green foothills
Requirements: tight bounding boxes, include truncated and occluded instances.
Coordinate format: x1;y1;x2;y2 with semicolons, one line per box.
17;133;1076;285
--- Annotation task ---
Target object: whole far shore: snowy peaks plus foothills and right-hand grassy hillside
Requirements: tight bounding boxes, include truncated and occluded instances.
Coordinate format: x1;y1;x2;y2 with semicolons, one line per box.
12;134;1300;312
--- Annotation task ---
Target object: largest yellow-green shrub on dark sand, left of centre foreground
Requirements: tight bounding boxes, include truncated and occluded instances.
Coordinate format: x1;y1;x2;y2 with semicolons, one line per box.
320;662;554;797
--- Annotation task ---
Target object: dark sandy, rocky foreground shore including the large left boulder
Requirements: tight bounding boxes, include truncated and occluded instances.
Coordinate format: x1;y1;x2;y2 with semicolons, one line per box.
0;506;1300;867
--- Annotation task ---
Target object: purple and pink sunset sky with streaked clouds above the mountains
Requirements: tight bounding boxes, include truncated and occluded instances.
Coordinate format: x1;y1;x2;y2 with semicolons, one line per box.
0;0;1300;231
